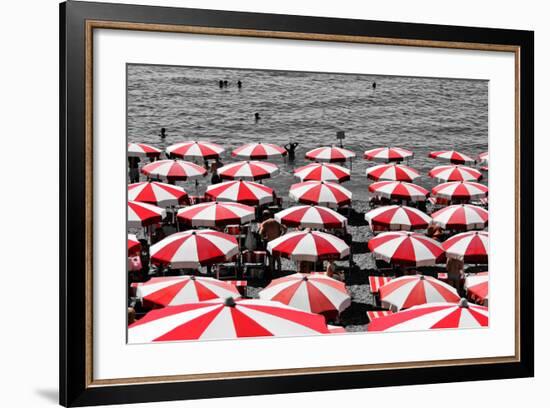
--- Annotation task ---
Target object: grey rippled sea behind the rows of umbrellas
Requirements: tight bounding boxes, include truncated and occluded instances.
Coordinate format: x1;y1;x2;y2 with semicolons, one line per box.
127;65;488;201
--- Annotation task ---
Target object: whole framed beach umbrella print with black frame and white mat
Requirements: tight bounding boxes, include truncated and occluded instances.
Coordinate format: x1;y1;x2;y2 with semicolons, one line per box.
60;1;534;406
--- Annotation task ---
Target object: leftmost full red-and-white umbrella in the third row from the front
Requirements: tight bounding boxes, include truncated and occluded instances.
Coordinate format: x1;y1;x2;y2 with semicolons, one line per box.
150;229;239;269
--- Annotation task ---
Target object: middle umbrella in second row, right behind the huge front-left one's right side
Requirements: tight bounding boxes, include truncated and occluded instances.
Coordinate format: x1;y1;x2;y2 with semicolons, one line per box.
259;273;351;313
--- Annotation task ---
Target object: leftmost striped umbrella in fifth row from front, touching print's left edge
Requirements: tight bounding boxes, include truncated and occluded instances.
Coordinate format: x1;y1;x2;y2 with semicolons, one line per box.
128;181;188;207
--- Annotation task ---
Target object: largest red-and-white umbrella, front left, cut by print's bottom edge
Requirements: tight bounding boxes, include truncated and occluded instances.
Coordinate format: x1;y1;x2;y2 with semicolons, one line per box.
128;298;330;343
